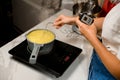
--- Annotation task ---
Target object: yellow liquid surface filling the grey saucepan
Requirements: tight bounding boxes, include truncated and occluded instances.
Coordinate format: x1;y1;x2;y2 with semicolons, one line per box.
26;29;55;44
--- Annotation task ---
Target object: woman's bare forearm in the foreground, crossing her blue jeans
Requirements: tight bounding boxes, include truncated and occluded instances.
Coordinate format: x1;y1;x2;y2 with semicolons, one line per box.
88;37;120;80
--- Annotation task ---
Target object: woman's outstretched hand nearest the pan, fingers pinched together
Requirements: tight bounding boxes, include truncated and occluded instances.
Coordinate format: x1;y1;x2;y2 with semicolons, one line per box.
54;15;79;28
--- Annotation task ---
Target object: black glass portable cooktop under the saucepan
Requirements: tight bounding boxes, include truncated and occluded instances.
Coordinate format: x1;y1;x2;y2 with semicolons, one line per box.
9;40;82;77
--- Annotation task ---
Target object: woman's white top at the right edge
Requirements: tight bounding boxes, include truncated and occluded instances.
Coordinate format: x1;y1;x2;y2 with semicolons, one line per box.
102;3;120;60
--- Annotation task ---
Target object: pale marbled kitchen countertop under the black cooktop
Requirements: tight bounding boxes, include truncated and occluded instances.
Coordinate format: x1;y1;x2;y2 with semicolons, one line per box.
0;9;92;80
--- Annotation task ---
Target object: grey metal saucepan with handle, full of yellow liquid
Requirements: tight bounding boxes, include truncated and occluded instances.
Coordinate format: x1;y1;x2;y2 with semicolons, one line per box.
26;29;55;64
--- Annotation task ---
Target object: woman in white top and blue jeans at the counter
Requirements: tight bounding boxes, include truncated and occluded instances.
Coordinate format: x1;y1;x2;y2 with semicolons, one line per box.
54;3;120;80
